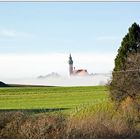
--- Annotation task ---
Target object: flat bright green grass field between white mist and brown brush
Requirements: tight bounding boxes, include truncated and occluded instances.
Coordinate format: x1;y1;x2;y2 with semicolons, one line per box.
0;86;108;110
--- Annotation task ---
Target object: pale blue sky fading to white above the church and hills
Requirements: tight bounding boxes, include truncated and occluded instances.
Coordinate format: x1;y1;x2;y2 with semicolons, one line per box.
0;2;140;78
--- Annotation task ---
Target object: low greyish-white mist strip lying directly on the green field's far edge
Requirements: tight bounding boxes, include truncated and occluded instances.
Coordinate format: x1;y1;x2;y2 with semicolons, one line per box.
2;75;111;86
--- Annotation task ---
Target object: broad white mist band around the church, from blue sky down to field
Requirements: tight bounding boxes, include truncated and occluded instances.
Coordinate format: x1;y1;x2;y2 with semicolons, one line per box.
0;53;114;86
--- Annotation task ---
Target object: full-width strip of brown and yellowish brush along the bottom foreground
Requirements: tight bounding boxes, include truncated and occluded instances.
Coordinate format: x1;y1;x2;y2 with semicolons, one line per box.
0;105;140;139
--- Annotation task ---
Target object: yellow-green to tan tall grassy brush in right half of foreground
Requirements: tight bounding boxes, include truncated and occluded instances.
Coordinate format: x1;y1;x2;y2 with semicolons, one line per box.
65;102;139;139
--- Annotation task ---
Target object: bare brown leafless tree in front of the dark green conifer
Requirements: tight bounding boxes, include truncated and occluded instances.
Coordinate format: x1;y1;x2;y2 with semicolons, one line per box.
110;53;140;102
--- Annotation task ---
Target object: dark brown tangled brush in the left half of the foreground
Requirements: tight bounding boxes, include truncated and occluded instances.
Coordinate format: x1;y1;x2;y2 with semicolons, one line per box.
0;112;65;139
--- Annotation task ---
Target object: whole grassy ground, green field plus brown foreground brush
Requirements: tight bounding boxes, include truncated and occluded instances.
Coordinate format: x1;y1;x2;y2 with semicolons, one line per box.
0;86;140;139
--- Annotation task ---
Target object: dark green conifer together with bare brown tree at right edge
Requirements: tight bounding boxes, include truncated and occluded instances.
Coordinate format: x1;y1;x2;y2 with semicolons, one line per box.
110;23;140;102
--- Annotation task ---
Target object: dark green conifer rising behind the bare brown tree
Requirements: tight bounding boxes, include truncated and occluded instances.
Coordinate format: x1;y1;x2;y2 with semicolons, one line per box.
114;23;140;71
